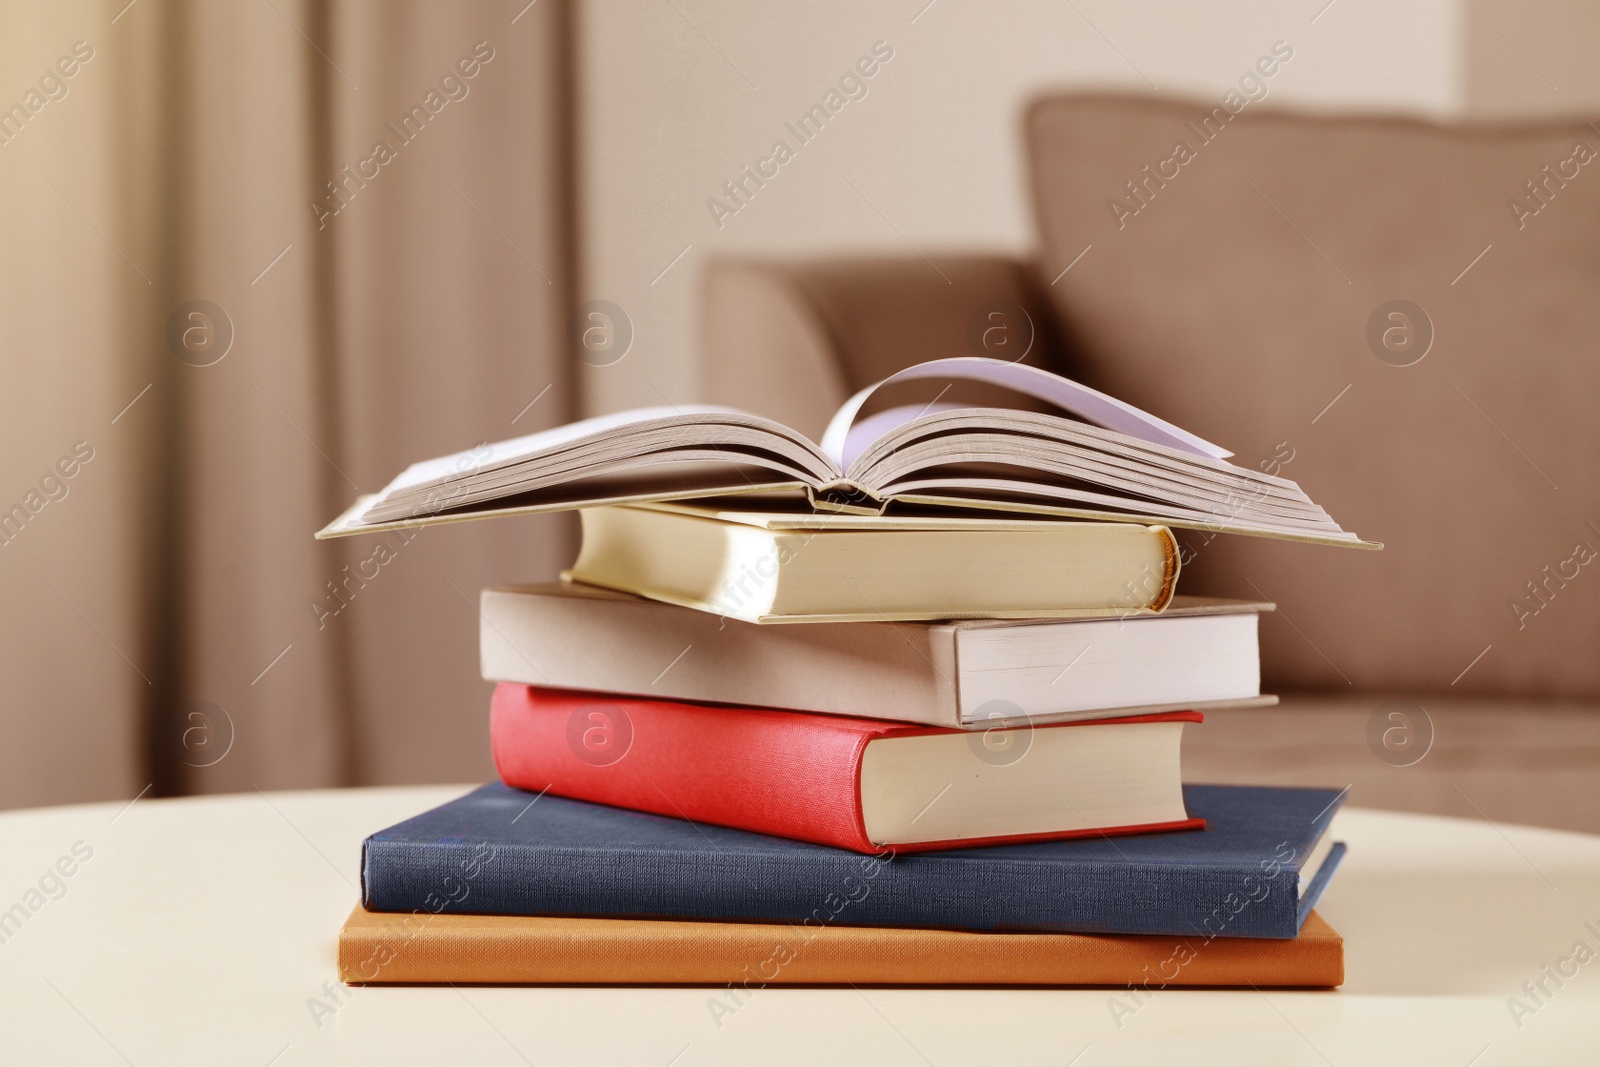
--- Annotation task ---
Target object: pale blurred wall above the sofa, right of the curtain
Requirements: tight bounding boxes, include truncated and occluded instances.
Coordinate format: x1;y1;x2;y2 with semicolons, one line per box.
579;0;1472;410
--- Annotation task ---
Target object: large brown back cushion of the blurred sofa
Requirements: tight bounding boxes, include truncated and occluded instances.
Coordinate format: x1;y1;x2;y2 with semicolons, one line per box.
1027;96;1600;696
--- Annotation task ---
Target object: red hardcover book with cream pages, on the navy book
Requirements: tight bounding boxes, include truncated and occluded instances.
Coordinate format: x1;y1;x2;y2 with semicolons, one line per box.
490;685;1205;853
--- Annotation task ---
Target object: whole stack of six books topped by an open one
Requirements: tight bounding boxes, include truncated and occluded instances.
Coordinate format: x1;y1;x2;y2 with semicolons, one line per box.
323;360;1368;991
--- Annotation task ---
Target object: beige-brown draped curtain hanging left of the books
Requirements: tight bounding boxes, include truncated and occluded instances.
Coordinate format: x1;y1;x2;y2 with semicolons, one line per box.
0;0;573;806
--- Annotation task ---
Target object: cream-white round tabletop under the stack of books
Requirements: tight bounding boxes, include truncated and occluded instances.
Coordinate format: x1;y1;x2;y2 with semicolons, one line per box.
0;785;1600;1067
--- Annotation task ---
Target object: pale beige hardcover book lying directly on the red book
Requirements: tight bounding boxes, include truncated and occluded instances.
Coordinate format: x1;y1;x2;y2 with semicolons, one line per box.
480;584;1277;729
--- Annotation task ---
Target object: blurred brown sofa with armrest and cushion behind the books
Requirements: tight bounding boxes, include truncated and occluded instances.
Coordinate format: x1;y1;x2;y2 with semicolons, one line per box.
701;94;1600;832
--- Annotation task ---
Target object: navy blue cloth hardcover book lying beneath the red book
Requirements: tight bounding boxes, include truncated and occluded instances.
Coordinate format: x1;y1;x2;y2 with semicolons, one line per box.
362;782;1344;937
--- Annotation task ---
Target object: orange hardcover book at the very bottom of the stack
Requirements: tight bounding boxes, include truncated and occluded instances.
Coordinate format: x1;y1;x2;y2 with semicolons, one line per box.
339;907;1344;990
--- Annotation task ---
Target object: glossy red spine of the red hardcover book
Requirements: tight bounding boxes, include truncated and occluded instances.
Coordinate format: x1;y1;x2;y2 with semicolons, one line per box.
490;685;882;853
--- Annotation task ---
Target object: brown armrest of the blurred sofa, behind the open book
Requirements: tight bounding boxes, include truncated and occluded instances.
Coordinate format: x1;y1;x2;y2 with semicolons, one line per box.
701;256;1061;438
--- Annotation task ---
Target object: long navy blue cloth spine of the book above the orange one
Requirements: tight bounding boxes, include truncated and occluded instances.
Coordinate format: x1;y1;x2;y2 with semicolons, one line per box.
362;837;1299;941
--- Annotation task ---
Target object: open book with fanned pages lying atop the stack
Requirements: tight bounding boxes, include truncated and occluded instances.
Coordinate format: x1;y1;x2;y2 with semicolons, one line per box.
317;357;1379;549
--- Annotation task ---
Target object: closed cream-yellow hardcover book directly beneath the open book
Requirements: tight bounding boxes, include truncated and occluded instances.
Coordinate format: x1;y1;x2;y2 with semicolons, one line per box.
562;504;1178;622
